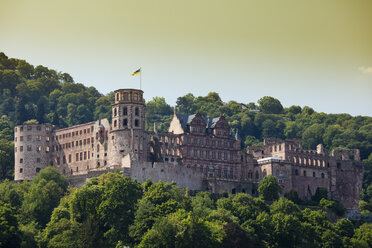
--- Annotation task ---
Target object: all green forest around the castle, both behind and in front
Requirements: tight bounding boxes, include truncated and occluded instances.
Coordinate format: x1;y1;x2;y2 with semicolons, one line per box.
0;52;372;247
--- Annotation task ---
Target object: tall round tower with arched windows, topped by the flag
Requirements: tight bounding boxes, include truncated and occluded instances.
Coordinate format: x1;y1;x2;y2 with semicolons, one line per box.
109;89;147;166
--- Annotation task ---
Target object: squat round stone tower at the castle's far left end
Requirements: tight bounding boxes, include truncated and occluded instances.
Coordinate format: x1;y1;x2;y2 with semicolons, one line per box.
14;124;53;181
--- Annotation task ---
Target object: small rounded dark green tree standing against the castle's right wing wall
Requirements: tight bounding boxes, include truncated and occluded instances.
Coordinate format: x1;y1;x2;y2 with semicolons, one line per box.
258;175;282;201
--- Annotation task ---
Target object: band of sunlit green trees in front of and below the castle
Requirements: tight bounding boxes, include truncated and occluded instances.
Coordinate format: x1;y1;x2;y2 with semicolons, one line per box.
0;167;372;248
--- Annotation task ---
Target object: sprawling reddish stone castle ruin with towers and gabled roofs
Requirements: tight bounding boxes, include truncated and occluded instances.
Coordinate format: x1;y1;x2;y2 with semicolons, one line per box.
14;89;363;209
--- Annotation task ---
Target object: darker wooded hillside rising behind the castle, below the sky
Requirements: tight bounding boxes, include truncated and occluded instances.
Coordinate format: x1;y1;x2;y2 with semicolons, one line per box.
0;53;372;211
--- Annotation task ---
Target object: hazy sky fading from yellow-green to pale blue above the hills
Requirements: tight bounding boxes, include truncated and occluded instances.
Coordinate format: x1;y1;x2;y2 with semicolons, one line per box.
0;0;372;116
